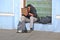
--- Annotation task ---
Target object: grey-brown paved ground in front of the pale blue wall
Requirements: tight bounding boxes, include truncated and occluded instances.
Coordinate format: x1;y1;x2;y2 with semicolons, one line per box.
0;30;60;40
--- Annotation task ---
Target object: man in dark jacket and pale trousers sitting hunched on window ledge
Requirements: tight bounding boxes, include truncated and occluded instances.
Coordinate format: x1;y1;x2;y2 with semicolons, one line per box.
19;4;37;32
